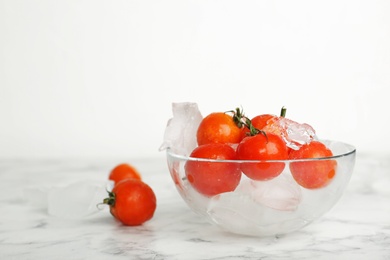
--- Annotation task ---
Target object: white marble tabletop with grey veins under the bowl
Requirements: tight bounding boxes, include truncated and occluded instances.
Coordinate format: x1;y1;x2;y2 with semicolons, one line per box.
0;153;390;260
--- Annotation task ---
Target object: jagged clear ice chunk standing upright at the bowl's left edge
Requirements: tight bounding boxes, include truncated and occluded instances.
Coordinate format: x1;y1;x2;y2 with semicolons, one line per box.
159;102;203;156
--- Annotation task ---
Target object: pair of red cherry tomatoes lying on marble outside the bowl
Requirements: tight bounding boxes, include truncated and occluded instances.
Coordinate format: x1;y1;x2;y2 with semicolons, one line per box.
103;163;157;226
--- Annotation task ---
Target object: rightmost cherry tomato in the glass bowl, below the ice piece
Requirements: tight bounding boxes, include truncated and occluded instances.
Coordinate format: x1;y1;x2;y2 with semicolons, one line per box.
289;141;337;189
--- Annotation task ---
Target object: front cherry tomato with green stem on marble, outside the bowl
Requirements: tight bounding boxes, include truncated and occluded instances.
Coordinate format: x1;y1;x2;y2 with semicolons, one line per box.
103;179;156;226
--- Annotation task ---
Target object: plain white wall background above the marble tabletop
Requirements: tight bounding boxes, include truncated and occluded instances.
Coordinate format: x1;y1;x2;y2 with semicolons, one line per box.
0;0;390;158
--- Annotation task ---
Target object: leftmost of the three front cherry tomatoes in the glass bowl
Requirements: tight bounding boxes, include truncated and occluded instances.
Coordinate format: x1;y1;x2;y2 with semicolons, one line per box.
185;143;241;196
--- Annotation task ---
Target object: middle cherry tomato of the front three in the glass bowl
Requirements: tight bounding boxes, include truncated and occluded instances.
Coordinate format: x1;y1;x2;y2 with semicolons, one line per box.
237;133;288;180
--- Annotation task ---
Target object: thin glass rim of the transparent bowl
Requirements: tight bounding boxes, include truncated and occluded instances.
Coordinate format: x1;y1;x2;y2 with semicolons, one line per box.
166;139;356;163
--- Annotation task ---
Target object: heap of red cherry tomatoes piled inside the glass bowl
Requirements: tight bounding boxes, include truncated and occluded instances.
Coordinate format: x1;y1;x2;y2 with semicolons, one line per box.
185;108;337;196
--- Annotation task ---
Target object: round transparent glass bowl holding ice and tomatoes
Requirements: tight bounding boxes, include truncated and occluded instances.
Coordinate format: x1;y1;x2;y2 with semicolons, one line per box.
167;140;356;236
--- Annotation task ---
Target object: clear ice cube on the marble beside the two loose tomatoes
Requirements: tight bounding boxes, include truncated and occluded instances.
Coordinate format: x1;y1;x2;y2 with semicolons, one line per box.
47;181;108;219
